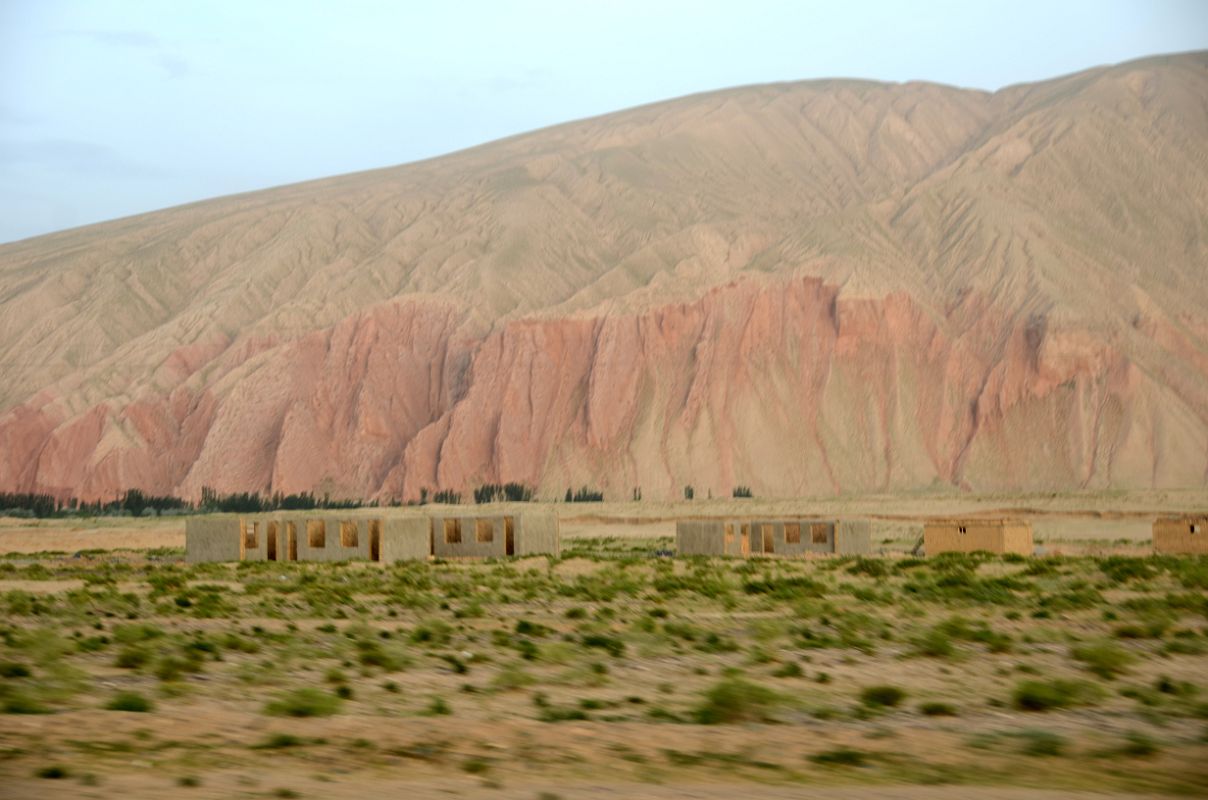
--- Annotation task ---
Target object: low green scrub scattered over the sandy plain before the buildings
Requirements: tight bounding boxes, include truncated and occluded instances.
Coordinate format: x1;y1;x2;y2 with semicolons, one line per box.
7;514;1208;794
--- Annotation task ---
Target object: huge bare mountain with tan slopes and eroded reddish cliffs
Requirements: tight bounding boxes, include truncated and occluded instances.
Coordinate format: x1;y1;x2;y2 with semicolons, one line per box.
0;53;1208;498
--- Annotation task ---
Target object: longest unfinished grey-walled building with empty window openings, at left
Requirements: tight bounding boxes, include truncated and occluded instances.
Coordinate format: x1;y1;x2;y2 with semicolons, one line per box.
185;512;561;563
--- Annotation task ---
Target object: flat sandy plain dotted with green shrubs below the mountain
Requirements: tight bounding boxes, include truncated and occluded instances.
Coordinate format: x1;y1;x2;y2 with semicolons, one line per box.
0;491;1208;800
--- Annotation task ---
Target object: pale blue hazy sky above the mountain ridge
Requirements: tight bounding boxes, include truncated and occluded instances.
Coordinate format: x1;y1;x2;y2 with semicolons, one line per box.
0;0;1208;242
